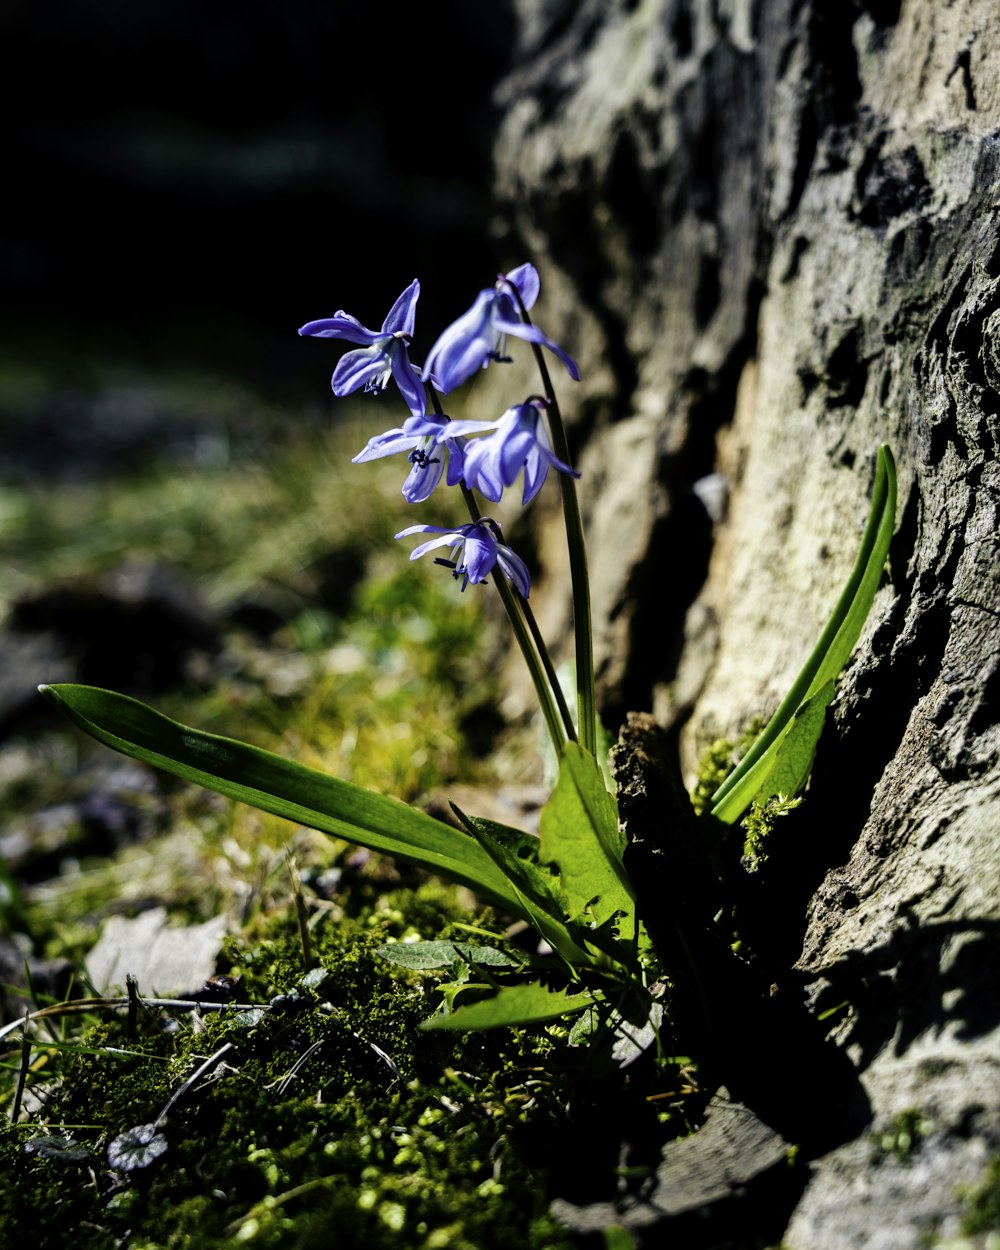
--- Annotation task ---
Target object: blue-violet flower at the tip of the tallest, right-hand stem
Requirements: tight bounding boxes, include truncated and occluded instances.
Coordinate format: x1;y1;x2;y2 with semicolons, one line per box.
424;264;580;393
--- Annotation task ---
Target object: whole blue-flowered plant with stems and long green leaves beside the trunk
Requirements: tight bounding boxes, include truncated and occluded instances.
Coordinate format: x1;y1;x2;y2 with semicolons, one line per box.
43;265;895;1045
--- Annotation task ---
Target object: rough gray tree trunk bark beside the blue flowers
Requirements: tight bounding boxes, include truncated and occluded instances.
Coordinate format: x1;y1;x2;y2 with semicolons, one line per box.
496;0;1000;1250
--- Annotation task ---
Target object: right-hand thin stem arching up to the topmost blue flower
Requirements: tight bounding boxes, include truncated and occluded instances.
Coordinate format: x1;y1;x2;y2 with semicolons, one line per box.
509;283;598;759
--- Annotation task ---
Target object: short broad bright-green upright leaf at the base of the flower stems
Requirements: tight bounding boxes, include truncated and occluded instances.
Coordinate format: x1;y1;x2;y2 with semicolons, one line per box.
539;743;635;941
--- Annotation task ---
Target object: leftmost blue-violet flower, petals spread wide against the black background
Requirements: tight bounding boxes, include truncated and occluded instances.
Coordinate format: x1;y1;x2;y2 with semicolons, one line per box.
299;280;426;416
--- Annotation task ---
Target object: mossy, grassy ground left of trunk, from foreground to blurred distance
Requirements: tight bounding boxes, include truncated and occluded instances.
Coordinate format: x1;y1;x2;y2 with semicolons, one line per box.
0;370;669;1250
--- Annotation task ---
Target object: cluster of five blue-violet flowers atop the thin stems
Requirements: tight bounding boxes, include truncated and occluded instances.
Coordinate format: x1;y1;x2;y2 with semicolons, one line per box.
299;264;580;599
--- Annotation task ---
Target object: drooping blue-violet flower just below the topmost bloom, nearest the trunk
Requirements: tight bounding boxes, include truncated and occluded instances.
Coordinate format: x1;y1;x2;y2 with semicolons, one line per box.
445;398;580;504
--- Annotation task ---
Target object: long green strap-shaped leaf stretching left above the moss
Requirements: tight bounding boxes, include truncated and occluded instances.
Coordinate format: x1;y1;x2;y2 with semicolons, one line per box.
41;685;531;920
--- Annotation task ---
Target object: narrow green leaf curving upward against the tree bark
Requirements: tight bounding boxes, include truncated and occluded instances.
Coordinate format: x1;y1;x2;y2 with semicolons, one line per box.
713;445;896;824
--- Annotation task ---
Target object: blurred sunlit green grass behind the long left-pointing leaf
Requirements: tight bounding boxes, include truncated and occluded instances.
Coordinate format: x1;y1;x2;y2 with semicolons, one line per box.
0;370;512;945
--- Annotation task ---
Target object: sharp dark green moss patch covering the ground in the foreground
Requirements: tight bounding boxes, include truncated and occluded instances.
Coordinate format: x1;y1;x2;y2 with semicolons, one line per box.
0;883;585;1250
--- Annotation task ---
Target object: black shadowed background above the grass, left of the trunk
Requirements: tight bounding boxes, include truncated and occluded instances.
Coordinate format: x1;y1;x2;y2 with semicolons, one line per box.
0;0;515;395
